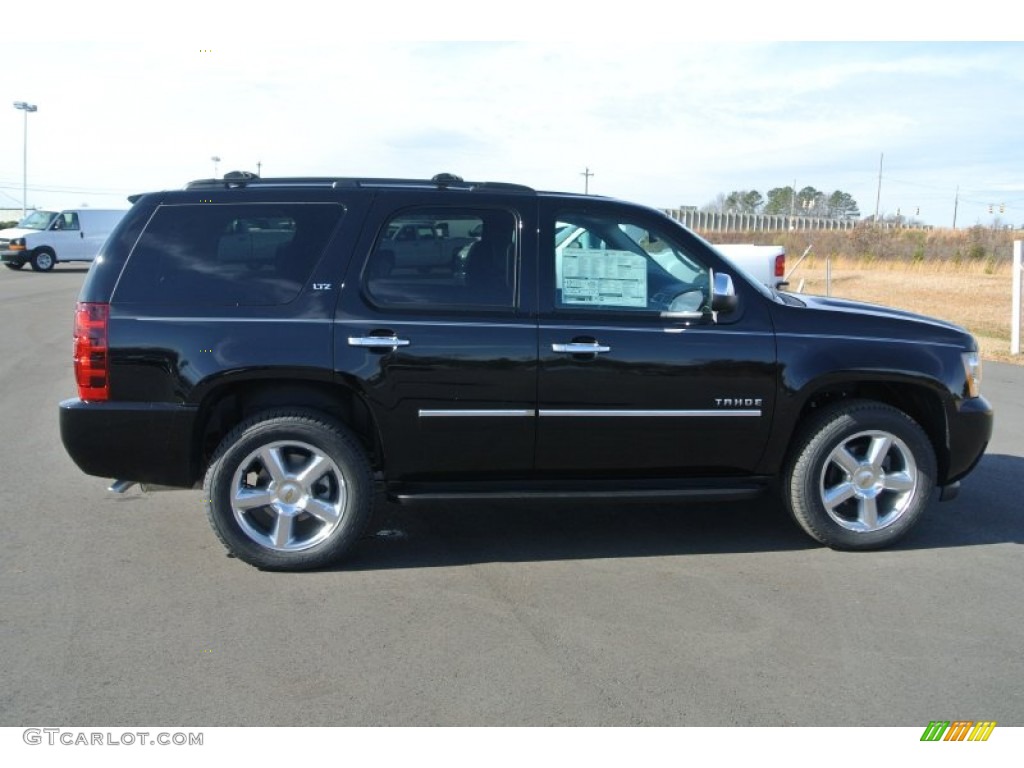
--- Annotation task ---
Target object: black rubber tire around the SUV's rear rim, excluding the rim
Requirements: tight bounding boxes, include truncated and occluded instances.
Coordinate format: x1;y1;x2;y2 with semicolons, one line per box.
203;414;373;570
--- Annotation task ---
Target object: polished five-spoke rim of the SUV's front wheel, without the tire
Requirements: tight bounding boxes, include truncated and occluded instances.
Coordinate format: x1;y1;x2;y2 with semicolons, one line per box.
819;430;919;532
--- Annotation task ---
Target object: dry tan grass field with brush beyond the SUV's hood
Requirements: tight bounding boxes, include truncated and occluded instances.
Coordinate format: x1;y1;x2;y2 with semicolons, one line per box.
703;226;1024;365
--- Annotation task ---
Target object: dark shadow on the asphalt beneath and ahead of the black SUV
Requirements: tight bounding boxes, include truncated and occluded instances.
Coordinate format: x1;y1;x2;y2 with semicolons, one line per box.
338;455;1024;570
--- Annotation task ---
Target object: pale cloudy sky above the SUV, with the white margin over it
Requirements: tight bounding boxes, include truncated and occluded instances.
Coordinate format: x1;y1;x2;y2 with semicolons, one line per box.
6;5;1024;226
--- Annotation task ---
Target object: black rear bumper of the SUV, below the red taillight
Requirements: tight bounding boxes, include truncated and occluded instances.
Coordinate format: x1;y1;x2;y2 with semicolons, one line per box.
60;397;199;487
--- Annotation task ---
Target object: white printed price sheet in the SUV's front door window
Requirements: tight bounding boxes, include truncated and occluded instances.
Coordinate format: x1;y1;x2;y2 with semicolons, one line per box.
561;248;647;308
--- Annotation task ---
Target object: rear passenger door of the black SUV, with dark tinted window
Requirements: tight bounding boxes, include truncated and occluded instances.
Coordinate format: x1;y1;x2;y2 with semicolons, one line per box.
335;191;537;480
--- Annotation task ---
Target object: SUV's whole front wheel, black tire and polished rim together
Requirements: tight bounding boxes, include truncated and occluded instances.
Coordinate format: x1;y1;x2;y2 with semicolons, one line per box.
782;400;936;550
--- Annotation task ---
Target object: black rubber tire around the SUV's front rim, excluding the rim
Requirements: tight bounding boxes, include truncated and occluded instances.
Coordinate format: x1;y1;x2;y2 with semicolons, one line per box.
785;401;936;550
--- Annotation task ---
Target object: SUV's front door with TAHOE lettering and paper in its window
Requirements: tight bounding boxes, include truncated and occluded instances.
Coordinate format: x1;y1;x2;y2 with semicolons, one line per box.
537;198;776;477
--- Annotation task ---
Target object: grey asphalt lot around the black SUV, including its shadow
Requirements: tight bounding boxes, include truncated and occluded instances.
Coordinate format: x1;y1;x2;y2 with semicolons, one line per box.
0;265;1024;727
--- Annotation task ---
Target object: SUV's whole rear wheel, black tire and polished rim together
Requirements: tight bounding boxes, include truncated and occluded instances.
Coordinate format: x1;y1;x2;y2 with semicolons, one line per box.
203;409;374;570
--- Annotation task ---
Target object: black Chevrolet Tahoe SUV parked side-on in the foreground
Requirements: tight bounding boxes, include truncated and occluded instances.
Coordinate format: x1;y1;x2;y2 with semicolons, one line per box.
60;173;992;569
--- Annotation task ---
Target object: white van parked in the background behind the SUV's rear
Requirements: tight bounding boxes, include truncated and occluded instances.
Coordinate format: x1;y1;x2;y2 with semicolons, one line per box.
0;208;128;272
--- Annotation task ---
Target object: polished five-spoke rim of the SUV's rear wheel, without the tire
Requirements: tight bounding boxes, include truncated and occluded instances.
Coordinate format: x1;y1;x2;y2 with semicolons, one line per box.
230;440;347;552
